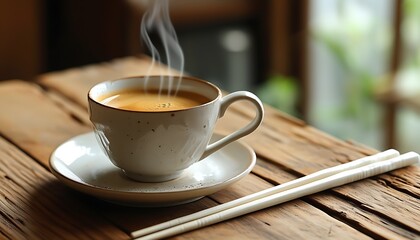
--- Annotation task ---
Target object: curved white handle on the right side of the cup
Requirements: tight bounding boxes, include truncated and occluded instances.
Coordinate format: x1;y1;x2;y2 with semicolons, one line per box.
201;91;264;159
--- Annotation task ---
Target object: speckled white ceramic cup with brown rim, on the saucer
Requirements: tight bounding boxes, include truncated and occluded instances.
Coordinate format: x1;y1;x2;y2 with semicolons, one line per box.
88;76;264;182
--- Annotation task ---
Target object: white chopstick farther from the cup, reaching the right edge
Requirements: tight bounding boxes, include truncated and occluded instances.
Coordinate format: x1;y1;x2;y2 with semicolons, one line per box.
138;152;420;239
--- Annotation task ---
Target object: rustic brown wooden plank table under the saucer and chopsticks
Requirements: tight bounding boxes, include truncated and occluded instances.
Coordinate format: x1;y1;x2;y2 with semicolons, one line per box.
0;57;420;239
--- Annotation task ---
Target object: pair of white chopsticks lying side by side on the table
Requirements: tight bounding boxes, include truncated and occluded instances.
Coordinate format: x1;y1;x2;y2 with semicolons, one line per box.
131;149;420;239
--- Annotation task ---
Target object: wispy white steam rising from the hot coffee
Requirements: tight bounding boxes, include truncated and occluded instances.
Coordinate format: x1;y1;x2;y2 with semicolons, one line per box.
140;0;184;95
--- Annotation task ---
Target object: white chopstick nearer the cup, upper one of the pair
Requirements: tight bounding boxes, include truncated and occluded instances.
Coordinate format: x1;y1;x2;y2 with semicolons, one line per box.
131;149;399;238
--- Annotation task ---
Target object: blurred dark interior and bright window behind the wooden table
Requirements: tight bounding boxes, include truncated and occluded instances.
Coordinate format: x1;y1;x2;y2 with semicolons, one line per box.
0;0;420;151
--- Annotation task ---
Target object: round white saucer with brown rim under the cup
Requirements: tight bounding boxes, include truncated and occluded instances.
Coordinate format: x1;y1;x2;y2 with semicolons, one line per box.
50;132;256;206
